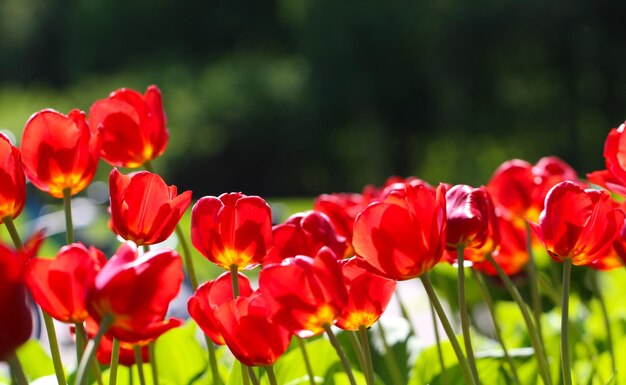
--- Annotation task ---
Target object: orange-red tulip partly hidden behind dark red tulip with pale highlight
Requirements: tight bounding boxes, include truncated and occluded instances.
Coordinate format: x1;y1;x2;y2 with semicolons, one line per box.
472;215;529;276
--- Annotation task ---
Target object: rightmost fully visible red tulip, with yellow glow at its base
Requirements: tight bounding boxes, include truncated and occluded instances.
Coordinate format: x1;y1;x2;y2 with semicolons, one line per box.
531;182;624;265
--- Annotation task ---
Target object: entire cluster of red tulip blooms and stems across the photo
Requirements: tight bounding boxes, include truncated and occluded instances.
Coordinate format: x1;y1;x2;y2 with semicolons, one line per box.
0;86;626;385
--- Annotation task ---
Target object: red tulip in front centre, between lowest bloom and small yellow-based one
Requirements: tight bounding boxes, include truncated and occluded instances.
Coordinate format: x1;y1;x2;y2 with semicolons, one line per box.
259;247;348;338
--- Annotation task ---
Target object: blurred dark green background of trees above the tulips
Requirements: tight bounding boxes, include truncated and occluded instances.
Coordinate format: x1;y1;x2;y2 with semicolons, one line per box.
0;0;626;197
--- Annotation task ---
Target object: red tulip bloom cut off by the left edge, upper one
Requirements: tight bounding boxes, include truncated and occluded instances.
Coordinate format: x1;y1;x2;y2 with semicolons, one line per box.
0;133;26;223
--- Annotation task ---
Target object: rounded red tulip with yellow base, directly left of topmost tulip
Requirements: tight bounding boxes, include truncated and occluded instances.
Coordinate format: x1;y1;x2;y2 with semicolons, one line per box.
21;110;102;198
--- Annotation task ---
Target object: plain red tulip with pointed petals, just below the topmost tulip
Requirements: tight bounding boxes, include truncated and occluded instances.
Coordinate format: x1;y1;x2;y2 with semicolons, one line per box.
109;168;191;245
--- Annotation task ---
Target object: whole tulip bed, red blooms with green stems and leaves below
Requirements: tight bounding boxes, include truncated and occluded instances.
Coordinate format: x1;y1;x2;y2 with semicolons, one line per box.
0;86;626;385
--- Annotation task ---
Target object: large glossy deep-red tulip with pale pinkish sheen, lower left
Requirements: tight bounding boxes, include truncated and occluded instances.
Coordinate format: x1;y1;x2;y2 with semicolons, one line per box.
87;242;183;345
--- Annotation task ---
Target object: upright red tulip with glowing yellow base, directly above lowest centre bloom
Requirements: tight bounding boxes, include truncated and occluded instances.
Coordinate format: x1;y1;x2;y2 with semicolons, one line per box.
191;193;272;270
